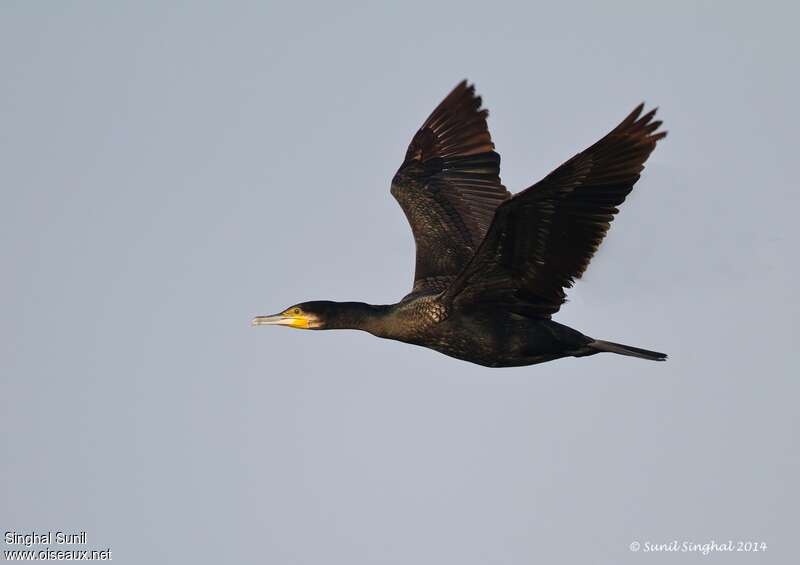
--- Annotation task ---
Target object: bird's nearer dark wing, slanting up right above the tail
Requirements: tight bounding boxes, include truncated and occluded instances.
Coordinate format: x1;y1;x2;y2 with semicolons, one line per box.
445;105;667;316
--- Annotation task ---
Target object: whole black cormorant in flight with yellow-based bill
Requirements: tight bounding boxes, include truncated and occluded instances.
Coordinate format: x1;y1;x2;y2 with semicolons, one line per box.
253;81;667;367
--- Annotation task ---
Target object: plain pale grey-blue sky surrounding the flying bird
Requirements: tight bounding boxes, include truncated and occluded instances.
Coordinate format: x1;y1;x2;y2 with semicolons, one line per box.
0;1;800;565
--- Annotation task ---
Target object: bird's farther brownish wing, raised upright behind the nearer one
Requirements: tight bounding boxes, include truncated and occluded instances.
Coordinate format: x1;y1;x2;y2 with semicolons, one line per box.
392;81;510;298
